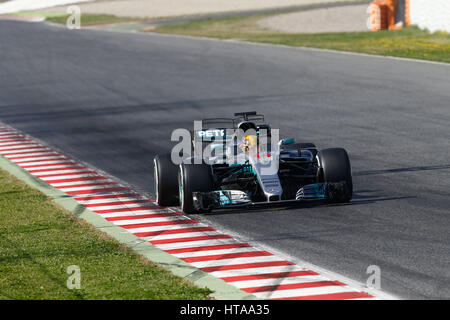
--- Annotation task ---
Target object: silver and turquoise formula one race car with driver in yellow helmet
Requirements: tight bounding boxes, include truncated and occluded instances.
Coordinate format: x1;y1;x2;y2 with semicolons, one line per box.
154;112;353;213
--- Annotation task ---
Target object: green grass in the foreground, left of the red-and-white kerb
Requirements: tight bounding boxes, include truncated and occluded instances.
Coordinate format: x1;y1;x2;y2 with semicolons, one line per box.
0;170;211;300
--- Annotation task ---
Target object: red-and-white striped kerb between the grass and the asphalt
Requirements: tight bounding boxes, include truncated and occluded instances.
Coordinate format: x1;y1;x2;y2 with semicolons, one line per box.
0;125;375;300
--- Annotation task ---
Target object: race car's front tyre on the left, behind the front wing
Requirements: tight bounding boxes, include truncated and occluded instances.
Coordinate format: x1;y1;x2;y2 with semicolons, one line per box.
178;163;213;213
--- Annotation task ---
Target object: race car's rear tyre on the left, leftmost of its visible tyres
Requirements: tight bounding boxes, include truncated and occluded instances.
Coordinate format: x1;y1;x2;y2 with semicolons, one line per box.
153;153;179;206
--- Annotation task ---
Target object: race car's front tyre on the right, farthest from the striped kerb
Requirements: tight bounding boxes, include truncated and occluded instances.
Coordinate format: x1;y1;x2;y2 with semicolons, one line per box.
318;148;353;203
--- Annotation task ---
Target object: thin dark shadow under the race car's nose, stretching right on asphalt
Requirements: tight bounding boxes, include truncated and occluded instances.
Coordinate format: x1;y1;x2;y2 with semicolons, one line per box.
202;190;417;216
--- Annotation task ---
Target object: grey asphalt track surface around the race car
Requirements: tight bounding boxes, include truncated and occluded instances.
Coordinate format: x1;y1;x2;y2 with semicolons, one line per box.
0;21;450;299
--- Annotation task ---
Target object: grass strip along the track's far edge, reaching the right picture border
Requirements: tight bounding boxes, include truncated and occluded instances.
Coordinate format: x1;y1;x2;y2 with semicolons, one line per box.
154;14;450;62
